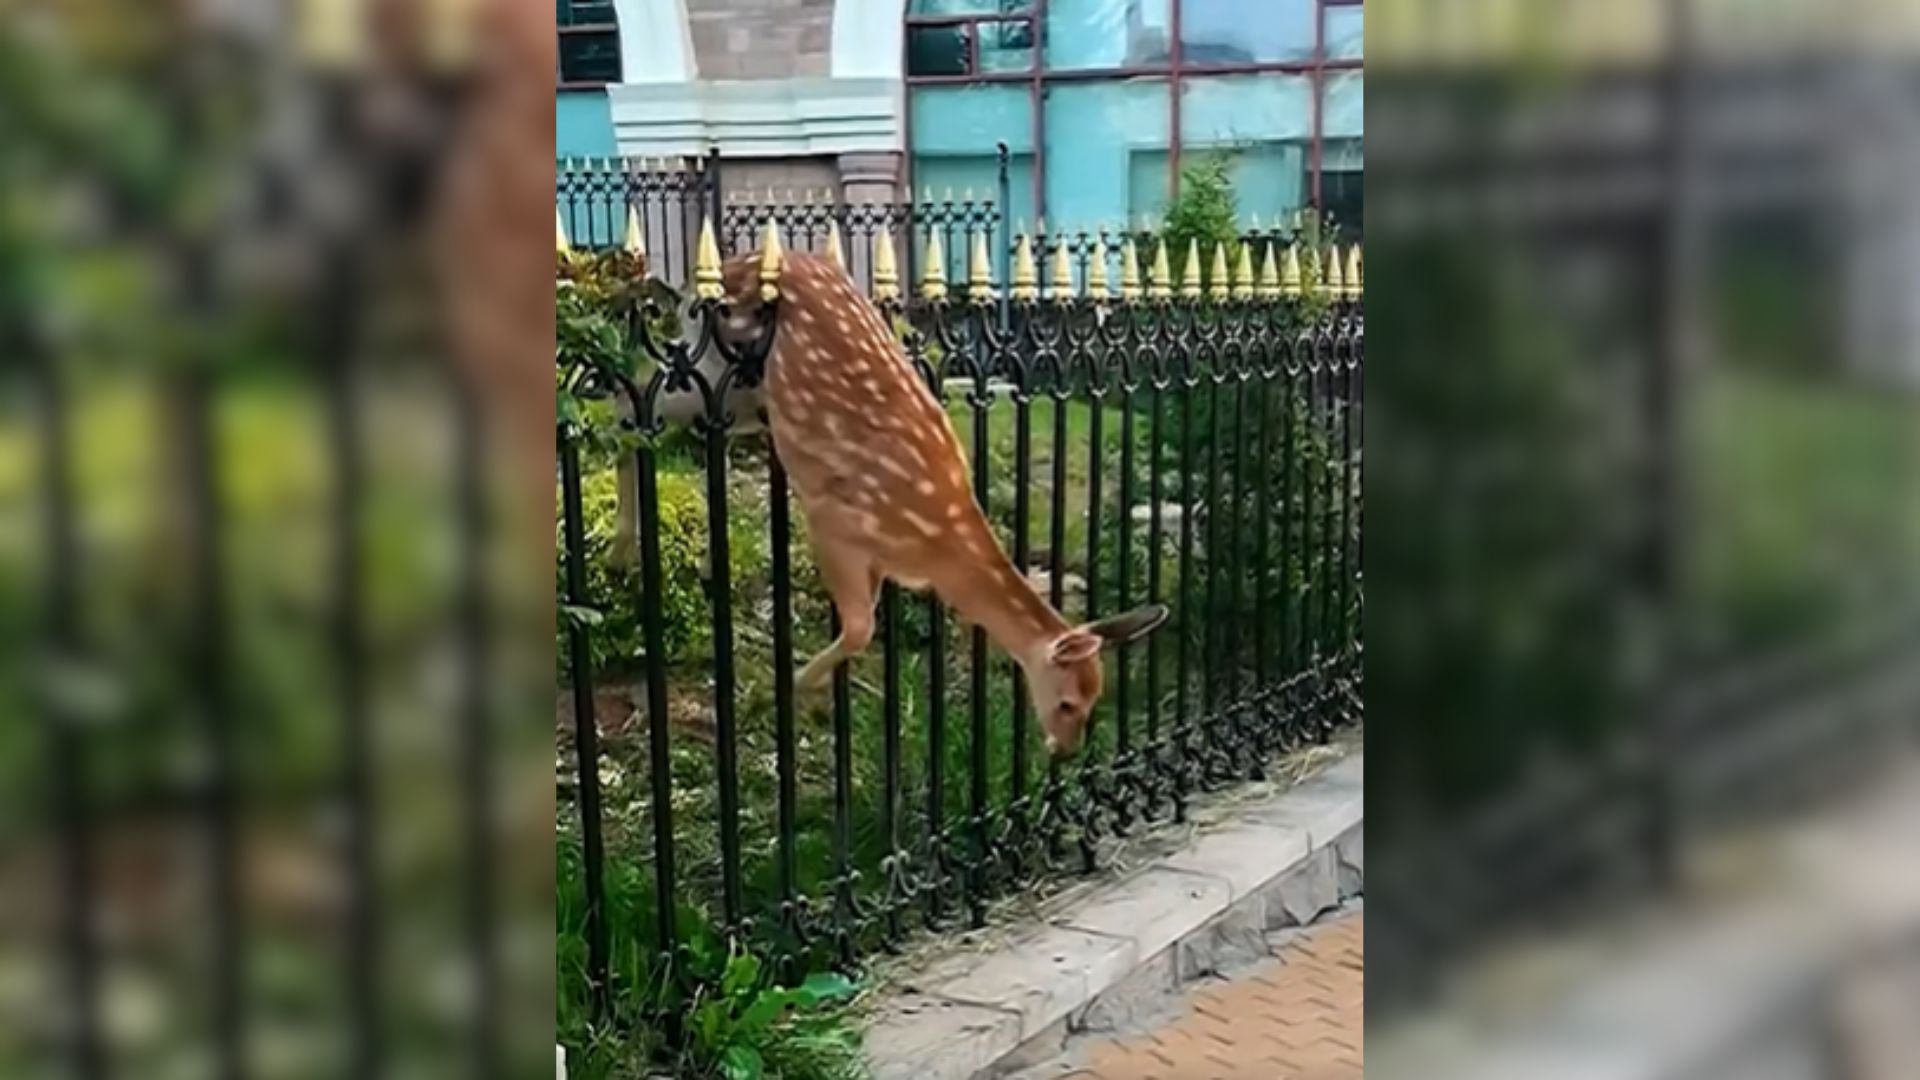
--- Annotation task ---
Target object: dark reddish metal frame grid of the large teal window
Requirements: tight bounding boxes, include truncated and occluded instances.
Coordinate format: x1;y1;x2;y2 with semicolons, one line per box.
900;0;1365;219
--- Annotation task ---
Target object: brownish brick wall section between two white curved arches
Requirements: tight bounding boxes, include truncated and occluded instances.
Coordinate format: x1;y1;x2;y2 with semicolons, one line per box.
687;0;833;79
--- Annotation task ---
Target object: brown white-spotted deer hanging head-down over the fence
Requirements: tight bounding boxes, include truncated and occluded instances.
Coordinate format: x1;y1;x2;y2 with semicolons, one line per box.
720;248;1169;761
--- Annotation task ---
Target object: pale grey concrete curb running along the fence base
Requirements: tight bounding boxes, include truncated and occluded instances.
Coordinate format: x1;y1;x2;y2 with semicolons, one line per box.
866;751;1365;1080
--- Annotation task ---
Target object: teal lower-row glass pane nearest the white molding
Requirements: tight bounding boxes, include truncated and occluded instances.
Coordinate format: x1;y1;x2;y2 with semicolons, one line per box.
912;85;1033;221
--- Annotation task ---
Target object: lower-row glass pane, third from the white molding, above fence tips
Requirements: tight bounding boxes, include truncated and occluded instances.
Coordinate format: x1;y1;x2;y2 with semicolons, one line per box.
1181;75;1313;221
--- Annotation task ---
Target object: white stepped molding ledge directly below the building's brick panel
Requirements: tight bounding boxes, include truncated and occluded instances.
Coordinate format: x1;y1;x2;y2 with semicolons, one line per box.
607;79;902;158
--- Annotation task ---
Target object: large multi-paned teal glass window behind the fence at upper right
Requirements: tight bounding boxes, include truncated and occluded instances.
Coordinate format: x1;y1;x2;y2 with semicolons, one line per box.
906;0;1365;229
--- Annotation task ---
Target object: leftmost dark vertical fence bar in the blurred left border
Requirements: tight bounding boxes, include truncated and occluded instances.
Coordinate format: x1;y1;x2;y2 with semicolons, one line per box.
37;357;108;1080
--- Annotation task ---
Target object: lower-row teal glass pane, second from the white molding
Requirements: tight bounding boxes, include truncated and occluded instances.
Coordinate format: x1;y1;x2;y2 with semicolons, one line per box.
1046;79;1171;231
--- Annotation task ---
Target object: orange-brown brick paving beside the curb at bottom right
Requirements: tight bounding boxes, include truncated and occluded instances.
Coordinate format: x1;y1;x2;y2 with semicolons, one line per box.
1066;913;1363;1080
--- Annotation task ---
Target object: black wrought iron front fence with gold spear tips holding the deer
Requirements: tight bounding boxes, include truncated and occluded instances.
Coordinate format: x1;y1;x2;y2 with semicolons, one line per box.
557;208;1365;1015
